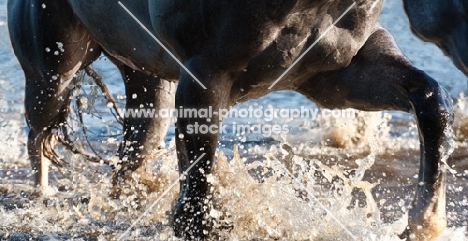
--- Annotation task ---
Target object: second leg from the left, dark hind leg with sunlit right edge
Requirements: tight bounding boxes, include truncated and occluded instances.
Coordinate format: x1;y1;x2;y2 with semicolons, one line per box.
113;65;175;191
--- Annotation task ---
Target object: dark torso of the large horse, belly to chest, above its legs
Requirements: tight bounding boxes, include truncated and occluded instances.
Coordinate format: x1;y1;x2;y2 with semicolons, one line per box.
68;0;382;79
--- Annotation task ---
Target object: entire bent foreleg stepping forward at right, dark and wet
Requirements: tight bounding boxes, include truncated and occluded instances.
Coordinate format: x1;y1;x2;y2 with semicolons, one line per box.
298;27;452;240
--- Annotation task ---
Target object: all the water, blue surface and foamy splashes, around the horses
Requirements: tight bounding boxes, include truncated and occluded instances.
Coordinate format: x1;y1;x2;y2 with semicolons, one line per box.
0;0;468;240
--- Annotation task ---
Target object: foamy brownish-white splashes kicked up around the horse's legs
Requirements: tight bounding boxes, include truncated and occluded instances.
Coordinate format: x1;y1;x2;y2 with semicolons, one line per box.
0;118;464;240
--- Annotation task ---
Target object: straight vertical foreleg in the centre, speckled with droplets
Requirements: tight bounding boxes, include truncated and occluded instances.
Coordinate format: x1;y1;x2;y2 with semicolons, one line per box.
174;59;230;240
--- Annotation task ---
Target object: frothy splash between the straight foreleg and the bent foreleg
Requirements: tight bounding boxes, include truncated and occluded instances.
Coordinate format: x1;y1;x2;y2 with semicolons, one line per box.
211;144;393;240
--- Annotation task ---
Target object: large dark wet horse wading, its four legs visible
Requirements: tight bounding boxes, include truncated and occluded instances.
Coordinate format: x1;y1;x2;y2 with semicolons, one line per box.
8;0;453;240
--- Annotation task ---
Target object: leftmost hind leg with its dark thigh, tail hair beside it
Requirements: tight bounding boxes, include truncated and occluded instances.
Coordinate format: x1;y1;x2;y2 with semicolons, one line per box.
8;0;100;186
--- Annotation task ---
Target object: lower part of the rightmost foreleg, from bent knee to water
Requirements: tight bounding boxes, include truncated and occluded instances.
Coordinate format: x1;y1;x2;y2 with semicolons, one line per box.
406;77;453;240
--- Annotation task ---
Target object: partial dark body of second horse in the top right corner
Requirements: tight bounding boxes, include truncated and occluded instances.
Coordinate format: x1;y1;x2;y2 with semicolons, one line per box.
403;0;468;76
